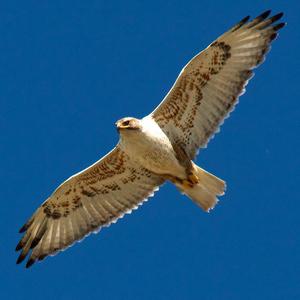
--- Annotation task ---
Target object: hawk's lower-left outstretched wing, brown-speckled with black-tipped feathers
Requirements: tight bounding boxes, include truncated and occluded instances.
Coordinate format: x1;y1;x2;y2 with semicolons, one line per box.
16;146;164;267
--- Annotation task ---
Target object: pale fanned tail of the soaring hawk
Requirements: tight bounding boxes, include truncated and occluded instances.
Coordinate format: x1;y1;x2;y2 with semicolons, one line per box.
176;163;226;212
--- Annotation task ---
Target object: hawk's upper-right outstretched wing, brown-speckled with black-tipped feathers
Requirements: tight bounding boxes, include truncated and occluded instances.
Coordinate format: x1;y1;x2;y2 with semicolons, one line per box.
151;11;285;159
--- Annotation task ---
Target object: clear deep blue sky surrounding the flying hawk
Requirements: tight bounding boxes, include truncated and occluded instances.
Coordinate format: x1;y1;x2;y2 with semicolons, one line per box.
0;0;300;300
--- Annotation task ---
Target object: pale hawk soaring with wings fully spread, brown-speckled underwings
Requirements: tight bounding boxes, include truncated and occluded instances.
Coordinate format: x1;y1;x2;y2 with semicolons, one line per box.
16;11;285;267
